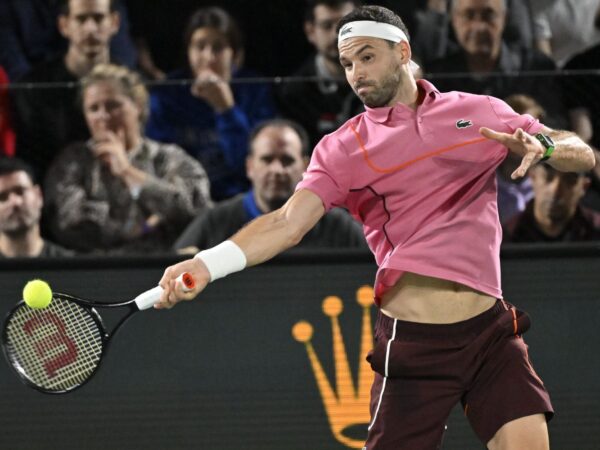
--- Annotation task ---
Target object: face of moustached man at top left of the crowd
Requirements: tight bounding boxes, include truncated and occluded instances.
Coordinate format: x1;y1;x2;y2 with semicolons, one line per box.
58;0;119;59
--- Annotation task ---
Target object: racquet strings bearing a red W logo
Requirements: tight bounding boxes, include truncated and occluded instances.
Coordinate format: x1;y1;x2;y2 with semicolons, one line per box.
6;296;103;392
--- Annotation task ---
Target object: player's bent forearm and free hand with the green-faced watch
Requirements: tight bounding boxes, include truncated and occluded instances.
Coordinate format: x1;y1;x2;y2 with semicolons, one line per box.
479;127;596;179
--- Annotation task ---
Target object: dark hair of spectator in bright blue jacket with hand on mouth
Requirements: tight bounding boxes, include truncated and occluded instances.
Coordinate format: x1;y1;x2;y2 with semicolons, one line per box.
183;6;244;55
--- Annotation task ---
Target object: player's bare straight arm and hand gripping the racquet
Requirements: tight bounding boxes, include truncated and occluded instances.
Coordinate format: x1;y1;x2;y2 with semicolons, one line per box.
155;189;325;309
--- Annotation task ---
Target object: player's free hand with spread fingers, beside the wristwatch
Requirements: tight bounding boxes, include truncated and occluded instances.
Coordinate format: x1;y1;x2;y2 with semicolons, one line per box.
479;127;546;180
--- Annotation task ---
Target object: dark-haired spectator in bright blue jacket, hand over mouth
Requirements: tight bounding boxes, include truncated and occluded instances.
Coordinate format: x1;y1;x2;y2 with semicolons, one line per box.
147;8;273;200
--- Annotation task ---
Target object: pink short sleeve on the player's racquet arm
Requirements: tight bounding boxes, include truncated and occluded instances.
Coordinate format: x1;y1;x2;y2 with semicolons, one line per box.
296;135;351;211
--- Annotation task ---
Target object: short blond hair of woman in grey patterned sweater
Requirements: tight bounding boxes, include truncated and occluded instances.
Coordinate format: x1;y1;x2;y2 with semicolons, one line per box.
81;64;149;123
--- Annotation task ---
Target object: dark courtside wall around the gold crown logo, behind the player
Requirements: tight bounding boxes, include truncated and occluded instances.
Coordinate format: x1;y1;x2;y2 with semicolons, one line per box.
0;245;600;450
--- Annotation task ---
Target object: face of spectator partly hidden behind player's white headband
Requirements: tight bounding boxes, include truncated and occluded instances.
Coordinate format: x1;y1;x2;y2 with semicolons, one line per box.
304;3;354;63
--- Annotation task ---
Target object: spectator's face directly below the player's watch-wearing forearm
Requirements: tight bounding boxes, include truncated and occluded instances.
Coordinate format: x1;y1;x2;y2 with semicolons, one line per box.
529;165;589;222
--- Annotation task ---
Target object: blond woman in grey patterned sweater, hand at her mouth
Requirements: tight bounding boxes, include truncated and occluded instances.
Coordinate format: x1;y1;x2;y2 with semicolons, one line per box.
46;64;210;252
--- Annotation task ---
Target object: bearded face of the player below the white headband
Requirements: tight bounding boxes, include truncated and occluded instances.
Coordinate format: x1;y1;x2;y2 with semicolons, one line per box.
339;36;410;108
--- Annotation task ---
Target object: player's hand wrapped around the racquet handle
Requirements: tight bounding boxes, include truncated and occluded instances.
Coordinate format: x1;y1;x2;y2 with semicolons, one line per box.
154;258;210;309
